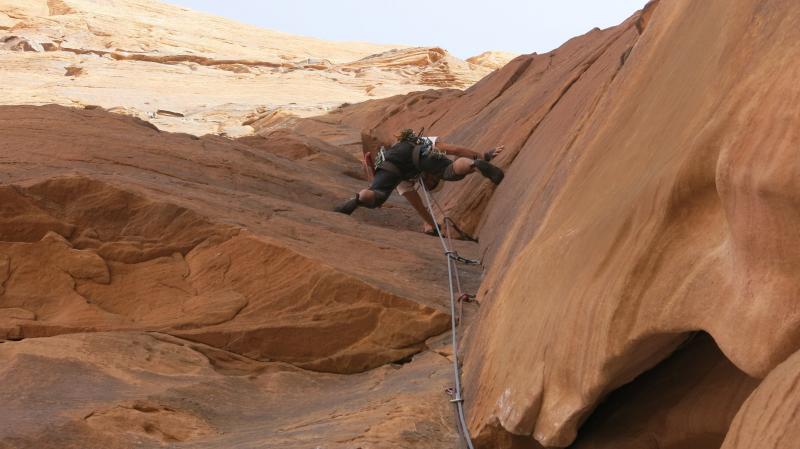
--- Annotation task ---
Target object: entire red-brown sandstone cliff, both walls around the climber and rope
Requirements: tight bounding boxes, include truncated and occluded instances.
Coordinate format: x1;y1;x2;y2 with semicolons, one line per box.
0;0;800;449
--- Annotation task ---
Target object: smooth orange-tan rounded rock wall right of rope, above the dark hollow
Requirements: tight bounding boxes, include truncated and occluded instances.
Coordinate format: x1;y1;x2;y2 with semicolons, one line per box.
456;1;800;447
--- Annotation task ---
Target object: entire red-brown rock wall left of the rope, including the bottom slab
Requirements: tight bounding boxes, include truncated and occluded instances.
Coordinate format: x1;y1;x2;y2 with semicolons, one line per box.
0;106;477;449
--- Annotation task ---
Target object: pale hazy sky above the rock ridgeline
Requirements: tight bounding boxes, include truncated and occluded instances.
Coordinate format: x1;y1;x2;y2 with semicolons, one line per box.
165;0;647;58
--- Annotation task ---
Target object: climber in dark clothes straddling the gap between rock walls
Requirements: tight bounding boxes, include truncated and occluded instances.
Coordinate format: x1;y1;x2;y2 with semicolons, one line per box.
334;129;504;220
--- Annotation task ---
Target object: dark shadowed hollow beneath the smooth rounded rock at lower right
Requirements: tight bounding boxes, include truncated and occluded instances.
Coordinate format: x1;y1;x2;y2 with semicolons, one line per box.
570;331;759;449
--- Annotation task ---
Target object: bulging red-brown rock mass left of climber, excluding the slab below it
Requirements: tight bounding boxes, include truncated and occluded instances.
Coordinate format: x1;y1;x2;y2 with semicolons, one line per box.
0;103;484;372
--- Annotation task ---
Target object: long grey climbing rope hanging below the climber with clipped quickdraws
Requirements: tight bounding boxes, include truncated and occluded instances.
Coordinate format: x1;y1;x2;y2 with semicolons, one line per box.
419;178;479;449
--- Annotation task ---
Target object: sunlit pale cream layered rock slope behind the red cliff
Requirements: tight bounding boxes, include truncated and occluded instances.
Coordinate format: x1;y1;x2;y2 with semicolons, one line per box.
0;0;495;137
